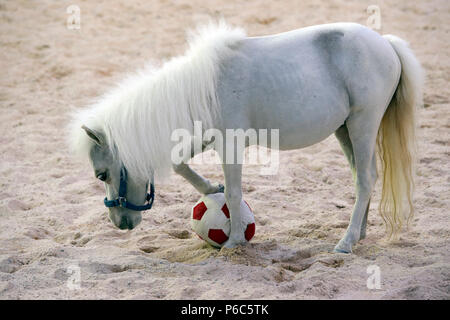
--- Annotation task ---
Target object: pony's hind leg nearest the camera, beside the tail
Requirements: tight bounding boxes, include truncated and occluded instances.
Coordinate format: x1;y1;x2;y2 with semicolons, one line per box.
334;114;379;253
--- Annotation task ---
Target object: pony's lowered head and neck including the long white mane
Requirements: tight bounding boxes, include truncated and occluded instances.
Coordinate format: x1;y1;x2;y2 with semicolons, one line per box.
69;21;245;229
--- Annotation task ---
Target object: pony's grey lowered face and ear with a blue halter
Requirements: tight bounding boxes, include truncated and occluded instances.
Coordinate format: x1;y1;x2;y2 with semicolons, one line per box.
82;125;154;229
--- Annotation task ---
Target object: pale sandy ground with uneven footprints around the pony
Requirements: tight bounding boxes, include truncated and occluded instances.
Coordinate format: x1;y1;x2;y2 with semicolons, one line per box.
0;0;450;299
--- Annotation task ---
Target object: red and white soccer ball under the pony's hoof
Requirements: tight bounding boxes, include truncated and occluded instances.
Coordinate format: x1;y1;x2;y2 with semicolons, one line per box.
191;193;255;248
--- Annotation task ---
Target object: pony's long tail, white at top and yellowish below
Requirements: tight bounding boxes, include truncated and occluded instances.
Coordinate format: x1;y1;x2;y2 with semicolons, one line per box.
377;35;423;238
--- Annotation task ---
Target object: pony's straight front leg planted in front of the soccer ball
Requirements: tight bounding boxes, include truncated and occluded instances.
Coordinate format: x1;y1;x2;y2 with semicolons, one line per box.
223;164;247;248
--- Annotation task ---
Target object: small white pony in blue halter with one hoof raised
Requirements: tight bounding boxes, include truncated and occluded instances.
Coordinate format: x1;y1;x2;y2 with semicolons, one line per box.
71;23;422;252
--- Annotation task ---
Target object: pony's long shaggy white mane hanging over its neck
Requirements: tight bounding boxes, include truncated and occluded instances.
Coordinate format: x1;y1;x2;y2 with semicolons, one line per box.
70;21;245;179
